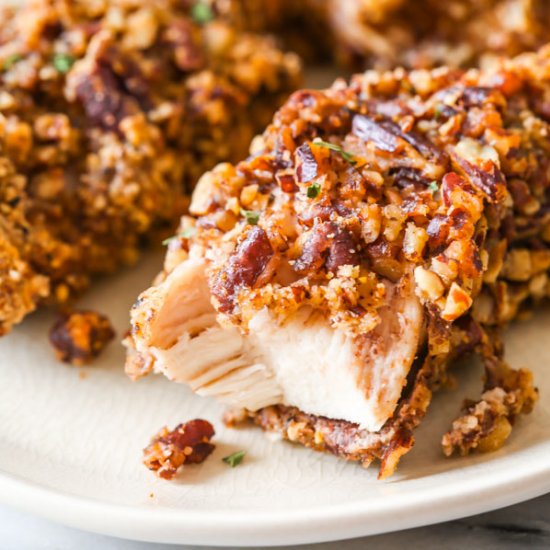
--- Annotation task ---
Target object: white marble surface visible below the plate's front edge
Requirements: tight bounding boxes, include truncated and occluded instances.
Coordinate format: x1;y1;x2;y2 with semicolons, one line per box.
0;494;550;550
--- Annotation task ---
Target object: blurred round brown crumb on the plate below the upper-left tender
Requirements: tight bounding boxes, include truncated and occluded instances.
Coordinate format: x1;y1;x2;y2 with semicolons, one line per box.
50;311;115;366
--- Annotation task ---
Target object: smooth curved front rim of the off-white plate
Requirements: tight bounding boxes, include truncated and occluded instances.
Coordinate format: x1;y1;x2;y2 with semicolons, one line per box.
0;442;550;547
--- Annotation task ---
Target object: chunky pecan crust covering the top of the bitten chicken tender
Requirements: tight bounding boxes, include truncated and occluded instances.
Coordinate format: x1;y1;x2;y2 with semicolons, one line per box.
184;53;548;336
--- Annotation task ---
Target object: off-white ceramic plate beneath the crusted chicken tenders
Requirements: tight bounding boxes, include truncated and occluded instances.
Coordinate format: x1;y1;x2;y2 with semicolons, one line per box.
0;256;550;546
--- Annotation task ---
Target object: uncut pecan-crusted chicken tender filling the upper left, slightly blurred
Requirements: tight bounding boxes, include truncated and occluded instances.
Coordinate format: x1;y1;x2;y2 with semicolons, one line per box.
0;0;300;334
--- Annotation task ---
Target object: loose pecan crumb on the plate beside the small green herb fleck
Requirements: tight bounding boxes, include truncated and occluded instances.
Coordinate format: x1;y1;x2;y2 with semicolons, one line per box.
143;418;216;479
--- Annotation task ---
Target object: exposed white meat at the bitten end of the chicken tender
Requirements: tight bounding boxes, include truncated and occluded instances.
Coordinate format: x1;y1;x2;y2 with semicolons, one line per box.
133;252;424;431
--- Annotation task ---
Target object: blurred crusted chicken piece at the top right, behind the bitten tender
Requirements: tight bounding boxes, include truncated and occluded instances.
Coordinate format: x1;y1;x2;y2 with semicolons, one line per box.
232;0;550;68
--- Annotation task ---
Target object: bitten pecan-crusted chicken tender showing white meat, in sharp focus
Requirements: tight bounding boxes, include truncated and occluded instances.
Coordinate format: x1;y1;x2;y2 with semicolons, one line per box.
126;48;550;477
